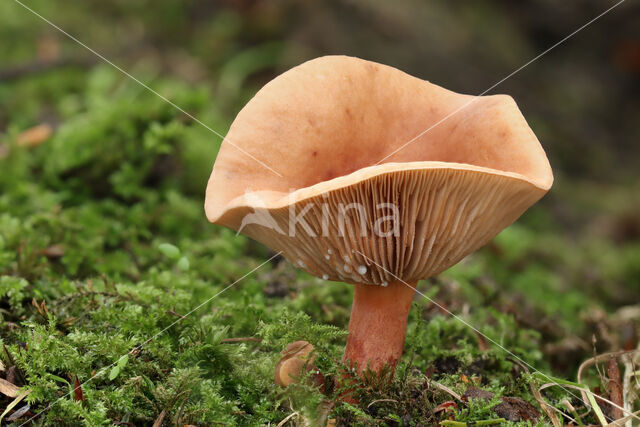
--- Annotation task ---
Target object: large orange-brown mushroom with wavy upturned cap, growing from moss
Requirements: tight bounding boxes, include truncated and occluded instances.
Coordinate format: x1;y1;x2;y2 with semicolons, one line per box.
205;56;553;373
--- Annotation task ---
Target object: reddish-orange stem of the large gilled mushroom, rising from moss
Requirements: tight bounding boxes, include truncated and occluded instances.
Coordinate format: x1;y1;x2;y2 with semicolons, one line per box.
342;282;416;374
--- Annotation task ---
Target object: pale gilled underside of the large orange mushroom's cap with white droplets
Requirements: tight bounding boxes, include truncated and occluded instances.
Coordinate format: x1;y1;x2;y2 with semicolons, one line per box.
216;162;548;286
